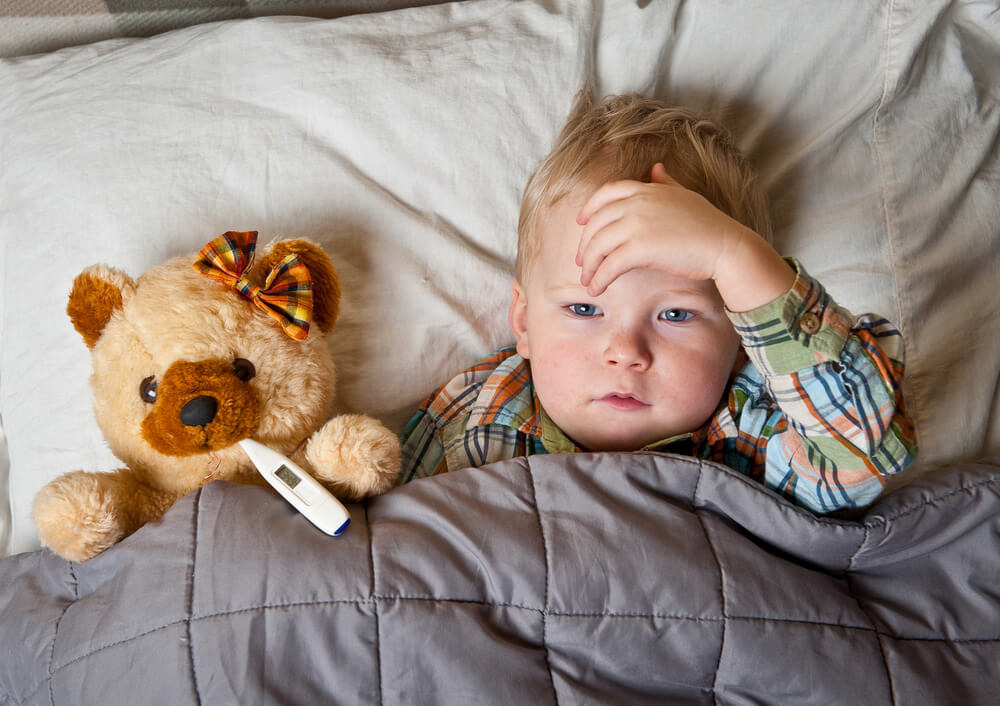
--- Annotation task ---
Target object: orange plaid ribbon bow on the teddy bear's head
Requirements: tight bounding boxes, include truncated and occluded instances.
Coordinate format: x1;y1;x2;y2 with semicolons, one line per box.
194;230;313;341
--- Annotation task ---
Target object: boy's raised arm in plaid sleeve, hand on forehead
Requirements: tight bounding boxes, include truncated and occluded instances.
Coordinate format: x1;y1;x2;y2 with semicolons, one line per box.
577;165;915;512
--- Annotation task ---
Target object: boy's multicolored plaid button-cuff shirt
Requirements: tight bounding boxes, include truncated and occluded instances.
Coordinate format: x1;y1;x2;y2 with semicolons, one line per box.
400;261;916;513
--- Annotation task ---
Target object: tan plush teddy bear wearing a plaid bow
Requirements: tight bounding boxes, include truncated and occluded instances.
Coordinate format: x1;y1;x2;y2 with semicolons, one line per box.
34;231;399;561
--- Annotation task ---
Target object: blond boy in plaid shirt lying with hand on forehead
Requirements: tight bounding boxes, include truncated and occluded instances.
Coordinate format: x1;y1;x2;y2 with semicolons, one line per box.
400;95;915;513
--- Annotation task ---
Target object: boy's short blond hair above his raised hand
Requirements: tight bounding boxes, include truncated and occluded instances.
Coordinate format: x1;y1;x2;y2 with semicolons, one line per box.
515;90;771;282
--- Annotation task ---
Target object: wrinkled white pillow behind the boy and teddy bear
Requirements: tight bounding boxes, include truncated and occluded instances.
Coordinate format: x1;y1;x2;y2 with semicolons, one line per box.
0;0;1000;551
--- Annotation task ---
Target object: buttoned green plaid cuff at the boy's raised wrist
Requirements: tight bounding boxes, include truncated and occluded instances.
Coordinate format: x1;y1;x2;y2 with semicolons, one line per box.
726;258;854;375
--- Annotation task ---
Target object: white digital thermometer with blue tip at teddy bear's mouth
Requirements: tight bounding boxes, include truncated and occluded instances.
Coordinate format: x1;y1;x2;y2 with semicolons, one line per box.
240;439;351;536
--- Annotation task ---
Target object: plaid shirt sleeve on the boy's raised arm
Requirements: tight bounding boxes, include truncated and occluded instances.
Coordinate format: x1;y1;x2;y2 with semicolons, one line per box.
729;260;916;513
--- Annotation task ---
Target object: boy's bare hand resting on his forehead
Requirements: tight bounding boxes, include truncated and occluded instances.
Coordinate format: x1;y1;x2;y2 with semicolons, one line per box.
576;163;794;311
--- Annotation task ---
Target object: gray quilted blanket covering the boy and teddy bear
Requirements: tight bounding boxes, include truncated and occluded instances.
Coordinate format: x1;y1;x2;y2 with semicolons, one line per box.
0;453;1000;705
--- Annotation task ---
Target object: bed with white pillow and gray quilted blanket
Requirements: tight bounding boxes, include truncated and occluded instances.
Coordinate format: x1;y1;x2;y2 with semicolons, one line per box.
0;0;1000;705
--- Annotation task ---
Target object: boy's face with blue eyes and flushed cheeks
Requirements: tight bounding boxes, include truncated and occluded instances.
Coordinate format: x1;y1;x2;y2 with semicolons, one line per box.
510;193;740;451
